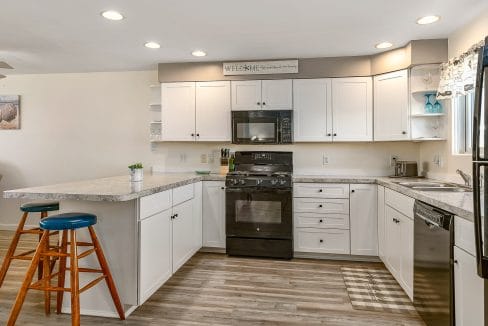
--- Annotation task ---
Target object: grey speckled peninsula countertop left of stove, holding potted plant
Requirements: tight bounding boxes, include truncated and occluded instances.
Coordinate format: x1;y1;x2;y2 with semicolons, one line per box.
3;173;225;201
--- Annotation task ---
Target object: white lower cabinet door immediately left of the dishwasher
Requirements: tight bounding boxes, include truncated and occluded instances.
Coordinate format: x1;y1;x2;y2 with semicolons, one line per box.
397;214;414;300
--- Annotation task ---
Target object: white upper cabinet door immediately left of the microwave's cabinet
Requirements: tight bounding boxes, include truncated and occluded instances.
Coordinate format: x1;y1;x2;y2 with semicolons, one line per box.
195;81;231;141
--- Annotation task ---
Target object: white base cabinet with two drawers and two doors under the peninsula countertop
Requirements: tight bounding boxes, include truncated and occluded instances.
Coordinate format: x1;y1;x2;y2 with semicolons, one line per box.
138;183;201;305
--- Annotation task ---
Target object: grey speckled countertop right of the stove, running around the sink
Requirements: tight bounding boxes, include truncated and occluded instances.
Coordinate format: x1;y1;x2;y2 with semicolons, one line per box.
293;175;473;221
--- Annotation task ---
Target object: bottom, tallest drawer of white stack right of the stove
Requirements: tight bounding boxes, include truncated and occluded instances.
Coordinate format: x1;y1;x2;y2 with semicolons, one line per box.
294;228;351;255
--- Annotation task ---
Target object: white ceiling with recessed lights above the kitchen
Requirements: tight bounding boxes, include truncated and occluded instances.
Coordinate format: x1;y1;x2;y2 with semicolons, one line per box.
0;0;488;74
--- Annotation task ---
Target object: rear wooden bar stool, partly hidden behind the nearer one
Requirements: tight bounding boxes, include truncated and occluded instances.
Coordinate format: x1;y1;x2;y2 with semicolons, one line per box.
0;201;59;287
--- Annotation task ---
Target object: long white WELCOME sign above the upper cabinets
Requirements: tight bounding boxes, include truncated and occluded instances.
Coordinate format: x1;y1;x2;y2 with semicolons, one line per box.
223;60;298;76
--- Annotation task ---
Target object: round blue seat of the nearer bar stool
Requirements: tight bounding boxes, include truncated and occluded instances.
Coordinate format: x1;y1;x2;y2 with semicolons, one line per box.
39;213;97;230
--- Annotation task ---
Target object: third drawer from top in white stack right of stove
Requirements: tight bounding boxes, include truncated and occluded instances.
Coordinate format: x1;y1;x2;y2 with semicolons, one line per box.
294;213;349;230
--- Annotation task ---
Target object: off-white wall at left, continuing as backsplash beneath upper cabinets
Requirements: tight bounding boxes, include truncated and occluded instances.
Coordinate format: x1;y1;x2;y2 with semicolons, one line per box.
0;71;419;228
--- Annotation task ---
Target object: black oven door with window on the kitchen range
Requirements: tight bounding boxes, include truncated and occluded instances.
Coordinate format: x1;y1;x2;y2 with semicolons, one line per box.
226;187;293;239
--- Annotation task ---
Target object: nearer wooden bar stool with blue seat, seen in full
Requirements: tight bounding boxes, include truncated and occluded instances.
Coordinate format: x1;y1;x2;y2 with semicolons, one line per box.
7;213;125;326
